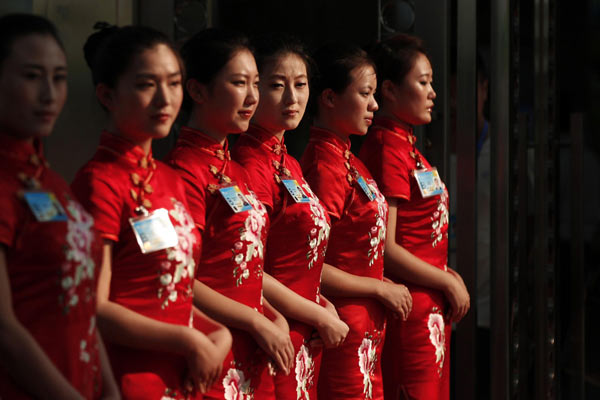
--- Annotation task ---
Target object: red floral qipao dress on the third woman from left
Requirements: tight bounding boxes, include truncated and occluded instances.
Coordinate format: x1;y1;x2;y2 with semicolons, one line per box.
167;127;274;400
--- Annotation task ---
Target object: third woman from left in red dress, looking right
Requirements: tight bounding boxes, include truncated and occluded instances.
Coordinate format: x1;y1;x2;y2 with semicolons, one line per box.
168;29;294;400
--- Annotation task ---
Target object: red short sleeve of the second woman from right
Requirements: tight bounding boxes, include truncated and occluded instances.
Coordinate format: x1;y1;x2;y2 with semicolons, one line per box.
304;163;347;220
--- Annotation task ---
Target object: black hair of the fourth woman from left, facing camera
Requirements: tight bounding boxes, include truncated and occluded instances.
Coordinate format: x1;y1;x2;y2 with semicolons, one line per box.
252;33;315;81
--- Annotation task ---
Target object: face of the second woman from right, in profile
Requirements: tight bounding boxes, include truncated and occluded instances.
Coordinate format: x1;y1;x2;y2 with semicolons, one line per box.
332;65;378;135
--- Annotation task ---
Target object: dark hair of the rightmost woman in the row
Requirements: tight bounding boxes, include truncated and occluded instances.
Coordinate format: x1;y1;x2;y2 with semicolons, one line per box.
370;33;429;83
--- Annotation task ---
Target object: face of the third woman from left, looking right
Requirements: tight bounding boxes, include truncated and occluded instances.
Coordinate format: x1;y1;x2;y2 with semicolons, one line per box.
201;50;259;136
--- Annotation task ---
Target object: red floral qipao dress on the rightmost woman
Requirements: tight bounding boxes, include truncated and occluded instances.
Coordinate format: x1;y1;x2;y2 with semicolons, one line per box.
360;118;452;399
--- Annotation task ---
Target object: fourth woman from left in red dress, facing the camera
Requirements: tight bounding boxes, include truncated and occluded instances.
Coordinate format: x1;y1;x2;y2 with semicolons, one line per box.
232;35;348;400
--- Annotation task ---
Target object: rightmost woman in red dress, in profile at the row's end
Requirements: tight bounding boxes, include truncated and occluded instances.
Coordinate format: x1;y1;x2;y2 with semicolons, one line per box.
361;35;469;399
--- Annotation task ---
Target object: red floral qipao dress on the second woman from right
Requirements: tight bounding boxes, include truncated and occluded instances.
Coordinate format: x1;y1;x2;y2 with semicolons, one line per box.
301;127;388;400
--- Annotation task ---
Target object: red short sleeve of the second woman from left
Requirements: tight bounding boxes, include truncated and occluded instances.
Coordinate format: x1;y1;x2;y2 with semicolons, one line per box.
71;170;123;241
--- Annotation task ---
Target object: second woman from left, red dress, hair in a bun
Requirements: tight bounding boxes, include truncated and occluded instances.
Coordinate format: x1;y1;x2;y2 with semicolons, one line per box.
72;26;231;399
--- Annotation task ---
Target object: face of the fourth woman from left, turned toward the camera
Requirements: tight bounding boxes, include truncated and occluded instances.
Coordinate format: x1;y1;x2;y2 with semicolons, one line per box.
252;53;309;134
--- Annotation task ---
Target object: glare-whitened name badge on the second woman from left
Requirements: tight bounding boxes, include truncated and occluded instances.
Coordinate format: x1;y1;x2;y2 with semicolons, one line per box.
129;208;179;254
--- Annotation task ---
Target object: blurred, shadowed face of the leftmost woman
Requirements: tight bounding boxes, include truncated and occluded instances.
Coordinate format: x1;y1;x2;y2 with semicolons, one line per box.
0;34;67;139
